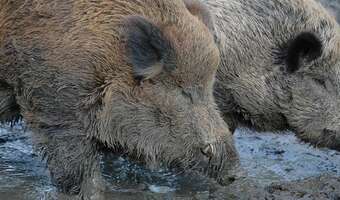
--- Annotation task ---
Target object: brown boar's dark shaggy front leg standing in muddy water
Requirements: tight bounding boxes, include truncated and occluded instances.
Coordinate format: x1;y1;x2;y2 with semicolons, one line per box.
33;127;104;199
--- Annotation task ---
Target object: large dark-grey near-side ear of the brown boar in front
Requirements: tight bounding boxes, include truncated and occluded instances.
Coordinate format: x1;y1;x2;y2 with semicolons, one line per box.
125;16;169;80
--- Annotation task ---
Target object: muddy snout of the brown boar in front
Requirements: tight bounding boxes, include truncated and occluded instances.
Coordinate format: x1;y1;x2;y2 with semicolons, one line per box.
175;106;237;178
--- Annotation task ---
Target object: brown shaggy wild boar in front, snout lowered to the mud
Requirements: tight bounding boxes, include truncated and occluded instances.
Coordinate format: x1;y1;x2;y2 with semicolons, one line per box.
0;0;237;195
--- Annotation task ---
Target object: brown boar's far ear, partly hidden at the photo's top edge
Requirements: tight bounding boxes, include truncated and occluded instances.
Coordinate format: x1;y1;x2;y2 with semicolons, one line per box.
183;0;215;32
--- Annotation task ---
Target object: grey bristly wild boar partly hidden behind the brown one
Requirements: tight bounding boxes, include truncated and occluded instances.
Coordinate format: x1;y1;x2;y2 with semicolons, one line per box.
205;0;340;150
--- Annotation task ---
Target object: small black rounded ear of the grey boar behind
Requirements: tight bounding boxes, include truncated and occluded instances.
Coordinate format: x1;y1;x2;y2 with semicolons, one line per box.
286;32;322;73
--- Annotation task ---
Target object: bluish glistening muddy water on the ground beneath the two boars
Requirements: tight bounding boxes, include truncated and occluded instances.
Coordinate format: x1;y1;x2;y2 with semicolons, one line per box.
0;125;340;200
